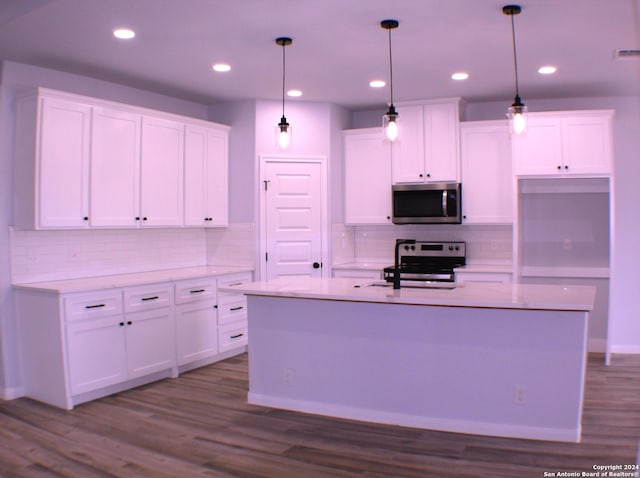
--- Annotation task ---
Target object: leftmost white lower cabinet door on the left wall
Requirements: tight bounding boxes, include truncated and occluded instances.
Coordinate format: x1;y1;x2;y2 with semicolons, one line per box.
67;316;127;395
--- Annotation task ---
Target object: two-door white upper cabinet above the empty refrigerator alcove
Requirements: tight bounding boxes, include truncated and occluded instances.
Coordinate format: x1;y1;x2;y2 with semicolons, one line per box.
513;110;613;176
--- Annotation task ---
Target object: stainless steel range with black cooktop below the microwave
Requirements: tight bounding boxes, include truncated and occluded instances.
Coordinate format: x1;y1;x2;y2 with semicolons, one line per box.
384;239;466;289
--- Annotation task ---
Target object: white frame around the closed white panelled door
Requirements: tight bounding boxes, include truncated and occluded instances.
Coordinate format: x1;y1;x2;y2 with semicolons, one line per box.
256;154;331;280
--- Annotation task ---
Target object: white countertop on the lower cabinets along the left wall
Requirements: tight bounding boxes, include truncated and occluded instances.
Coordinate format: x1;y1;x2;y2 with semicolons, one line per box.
13;266;253;294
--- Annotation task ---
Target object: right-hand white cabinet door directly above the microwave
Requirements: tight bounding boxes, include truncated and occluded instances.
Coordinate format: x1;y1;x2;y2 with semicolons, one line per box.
424;101;460;182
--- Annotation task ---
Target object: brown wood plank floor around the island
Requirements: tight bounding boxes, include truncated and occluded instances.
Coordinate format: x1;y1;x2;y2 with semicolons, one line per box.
0;354;640;478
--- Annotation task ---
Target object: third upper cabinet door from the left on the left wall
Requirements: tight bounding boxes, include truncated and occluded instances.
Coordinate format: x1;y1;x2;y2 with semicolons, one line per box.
137;116;184;226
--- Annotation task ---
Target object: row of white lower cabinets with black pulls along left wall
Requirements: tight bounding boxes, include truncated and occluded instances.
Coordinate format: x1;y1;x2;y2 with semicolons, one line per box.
15;272;252;409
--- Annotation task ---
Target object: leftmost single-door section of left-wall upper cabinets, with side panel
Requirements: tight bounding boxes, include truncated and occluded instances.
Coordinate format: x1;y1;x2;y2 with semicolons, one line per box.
14;96;91;229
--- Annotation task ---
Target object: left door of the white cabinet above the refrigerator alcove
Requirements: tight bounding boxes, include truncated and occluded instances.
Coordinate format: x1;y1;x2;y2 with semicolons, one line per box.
512;115;563;176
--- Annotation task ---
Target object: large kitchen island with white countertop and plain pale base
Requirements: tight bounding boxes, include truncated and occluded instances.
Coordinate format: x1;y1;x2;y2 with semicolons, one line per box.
222;278;595;442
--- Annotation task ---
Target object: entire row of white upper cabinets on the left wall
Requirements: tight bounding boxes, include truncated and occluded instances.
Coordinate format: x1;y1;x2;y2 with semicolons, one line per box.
14;88;229;229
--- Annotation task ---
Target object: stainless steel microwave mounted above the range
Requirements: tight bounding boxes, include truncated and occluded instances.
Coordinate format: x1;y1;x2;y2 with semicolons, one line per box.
391;183;462;224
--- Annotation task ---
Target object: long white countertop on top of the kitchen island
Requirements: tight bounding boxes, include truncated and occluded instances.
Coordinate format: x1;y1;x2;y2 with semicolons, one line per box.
220;278;596;311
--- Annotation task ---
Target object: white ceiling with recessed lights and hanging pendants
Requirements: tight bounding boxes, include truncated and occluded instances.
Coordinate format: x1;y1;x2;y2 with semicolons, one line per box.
0;0;640;109
